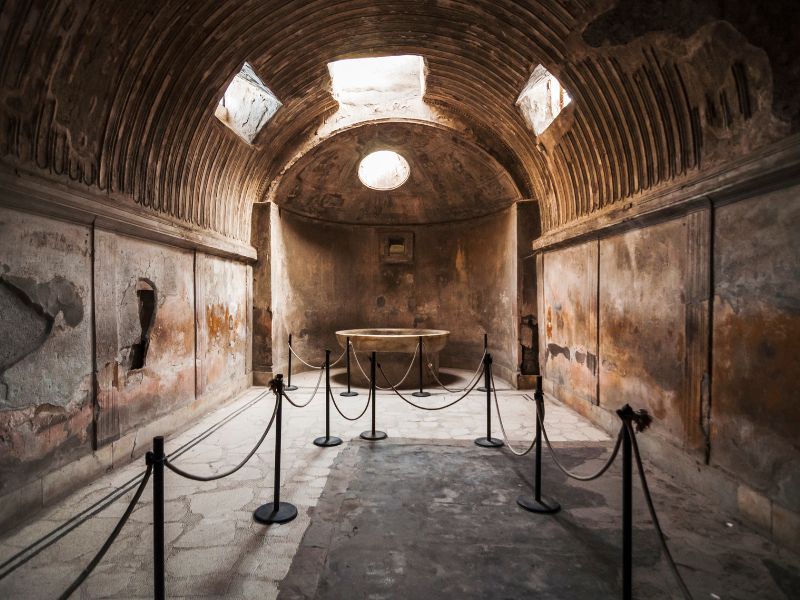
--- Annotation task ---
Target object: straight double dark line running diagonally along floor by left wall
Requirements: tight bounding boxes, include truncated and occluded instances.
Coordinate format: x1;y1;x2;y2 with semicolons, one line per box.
0;390;269;580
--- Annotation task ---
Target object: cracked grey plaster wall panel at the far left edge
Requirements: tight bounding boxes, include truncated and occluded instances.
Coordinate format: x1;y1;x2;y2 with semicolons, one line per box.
0;208;92;495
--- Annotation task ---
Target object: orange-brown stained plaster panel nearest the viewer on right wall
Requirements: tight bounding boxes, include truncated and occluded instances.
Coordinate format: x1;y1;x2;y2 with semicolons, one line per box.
710;187;800;533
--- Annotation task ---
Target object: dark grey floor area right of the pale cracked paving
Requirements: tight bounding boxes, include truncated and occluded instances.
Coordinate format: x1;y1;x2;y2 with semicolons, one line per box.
279;440;798;600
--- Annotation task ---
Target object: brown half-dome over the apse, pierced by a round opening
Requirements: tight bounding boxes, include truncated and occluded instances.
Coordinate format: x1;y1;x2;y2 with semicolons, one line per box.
273;122;521;225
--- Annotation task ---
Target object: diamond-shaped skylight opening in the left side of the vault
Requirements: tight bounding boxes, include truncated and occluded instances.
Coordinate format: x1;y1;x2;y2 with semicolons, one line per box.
214;63;283;144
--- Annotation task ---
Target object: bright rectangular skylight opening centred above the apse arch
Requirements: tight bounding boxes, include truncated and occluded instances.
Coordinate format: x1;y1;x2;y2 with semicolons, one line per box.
328;54;425;106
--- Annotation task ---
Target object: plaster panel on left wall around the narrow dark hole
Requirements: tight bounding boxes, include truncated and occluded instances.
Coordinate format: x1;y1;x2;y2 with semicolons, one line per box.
95;230;195;445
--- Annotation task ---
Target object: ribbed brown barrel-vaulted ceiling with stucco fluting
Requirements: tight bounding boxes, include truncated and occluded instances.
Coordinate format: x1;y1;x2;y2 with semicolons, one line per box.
0;0;800;241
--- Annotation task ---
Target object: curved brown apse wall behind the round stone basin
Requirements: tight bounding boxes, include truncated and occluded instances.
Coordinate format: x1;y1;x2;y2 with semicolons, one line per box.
272;208;519;379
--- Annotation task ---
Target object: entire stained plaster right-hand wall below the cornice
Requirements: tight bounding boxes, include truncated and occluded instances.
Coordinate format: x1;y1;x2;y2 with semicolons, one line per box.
539;187;800;546
